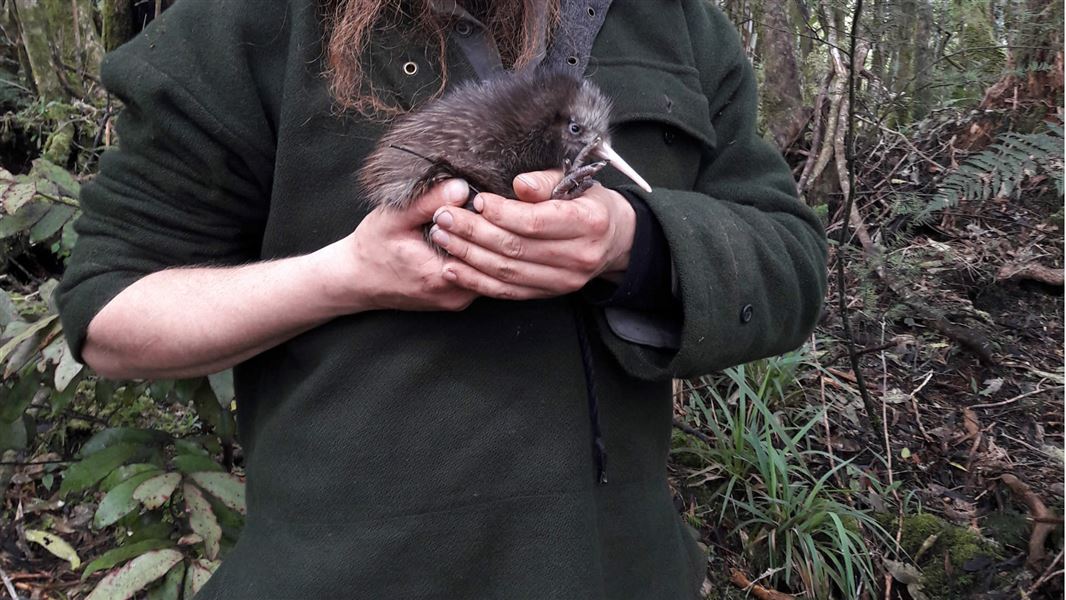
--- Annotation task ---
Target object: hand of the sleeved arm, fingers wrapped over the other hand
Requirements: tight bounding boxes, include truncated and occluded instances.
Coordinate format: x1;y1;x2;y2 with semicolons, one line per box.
433;169;636;299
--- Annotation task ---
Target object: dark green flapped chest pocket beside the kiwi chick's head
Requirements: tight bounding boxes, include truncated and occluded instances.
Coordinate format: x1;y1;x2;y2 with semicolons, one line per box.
589;59;717;190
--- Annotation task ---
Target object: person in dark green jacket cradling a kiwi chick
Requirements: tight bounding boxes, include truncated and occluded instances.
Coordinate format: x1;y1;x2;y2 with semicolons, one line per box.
56;0;826;600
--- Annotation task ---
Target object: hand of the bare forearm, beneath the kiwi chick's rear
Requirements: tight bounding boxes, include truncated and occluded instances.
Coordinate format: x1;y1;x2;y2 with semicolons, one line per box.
326;179;479;312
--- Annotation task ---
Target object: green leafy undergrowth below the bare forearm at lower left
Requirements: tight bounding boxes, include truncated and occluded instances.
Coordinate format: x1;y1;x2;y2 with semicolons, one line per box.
0;277;245;600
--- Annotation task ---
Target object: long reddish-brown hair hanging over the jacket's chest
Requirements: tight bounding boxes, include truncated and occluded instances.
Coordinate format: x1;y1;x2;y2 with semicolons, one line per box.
323;0;560;116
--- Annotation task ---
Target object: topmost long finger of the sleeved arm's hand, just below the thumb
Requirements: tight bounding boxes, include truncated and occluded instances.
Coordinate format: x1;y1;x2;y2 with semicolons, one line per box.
473;194;610;240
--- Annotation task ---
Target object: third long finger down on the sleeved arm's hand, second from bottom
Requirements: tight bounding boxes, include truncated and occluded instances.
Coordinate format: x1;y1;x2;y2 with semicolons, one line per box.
431;226;588;294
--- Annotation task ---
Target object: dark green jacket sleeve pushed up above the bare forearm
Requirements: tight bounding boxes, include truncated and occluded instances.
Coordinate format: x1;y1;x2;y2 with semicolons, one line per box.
55;0;274;359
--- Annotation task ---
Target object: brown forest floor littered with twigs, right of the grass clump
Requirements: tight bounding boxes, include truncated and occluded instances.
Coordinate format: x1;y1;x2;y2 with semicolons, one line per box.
675;110;1064;600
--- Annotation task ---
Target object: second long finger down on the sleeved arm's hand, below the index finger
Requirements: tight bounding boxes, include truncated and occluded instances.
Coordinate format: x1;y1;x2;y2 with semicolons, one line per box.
433;201;603;272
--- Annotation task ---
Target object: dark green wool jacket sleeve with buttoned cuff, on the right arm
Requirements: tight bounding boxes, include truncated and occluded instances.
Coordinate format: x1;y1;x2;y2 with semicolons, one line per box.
599;2;826;379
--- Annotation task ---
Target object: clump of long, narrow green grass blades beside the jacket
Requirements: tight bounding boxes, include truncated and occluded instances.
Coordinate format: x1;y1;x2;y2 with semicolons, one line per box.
675;354;887;598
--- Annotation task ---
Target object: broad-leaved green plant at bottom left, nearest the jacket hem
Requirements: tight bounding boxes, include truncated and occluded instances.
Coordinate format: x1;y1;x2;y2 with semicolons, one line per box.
60;417;246;598
